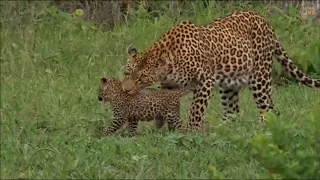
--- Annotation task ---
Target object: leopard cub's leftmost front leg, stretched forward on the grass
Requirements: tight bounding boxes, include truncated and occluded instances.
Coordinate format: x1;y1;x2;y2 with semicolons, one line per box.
104;111;127;136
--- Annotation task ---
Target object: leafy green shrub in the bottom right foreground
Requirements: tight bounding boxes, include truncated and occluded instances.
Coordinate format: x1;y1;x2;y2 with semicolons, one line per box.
219;105;320;179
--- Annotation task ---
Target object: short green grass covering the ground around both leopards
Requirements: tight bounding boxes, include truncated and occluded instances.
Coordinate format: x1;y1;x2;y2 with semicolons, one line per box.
0;1;320;179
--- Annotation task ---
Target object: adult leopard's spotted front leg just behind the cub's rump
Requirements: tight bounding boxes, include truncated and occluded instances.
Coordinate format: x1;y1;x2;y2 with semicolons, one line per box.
188;78;214;131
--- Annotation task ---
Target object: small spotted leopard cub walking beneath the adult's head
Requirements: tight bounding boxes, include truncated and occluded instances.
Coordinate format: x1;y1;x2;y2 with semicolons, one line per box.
98;77;188;136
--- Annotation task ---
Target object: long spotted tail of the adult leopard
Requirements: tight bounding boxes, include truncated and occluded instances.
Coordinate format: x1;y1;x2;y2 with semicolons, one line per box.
275;41;320;88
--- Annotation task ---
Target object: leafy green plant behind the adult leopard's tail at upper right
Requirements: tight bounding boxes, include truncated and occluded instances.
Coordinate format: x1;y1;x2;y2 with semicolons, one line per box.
268;6;320;81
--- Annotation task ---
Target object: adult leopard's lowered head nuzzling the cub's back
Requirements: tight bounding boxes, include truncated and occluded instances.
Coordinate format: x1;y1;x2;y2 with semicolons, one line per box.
124;45;172;92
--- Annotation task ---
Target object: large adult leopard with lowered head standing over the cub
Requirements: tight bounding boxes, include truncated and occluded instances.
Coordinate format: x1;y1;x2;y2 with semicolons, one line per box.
124;11;320;131
